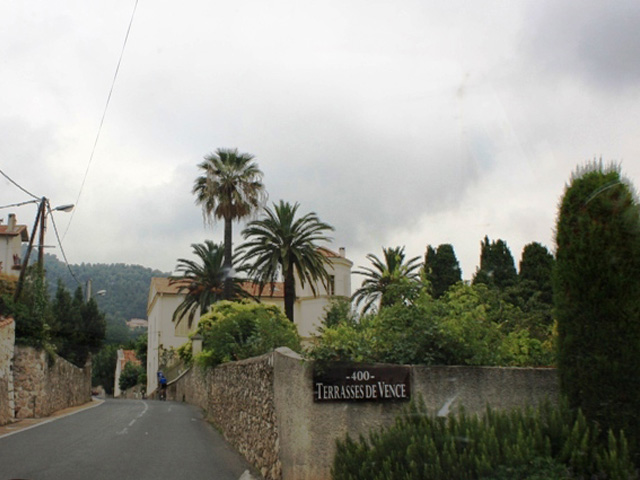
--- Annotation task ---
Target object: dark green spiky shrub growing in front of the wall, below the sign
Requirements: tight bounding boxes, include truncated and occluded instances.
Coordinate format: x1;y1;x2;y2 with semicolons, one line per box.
332;401;638;480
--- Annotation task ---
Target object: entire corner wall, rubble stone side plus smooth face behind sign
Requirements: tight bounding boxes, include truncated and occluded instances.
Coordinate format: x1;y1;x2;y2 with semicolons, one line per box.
169;348;559;480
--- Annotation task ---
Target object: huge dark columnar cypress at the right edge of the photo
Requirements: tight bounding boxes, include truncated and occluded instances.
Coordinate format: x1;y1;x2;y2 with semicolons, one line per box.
553;162;640;448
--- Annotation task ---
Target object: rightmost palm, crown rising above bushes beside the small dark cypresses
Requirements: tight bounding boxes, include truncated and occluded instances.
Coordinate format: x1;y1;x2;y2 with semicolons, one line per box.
351;247;421;313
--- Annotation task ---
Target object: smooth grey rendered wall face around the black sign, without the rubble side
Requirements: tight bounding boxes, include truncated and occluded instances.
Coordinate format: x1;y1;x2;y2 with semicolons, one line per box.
274;350;559;480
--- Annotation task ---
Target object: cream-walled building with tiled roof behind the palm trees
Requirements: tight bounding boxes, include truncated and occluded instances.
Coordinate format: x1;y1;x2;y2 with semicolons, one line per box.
147;247;353;393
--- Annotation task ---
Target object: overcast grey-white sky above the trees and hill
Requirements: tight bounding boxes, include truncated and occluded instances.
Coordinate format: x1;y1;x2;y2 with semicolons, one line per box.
0;0;640;284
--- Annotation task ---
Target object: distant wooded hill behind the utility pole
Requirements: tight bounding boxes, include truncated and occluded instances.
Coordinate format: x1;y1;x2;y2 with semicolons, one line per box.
44;254;169;323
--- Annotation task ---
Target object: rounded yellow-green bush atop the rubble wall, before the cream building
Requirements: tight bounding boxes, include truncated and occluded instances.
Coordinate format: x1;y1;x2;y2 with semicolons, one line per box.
196;301;300;366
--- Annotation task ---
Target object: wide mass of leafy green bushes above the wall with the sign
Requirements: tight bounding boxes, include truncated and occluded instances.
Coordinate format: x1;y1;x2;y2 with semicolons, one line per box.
308;284;554;366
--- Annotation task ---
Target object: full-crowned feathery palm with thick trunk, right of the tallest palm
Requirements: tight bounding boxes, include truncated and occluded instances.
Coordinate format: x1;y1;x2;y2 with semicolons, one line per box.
238;200;333;322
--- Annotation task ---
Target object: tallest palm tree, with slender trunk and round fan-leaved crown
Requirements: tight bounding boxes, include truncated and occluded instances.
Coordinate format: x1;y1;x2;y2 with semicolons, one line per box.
192;148;266;299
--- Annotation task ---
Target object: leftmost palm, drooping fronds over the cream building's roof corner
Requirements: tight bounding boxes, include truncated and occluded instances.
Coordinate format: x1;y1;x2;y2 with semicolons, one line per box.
169;240;245;327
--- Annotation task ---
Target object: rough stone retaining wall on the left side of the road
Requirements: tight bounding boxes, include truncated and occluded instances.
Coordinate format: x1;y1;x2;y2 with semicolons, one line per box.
13;346;91;419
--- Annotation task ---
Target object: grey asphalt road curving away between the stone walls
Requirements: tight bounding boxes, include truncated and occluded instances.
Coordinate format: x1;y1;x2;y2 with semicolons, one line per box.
0;400;260;480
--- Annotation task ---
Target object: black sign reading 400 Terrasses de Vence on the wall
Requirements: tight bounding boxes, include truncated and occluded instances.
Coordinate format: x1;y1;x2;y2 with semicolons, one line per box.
313;364;411;402
